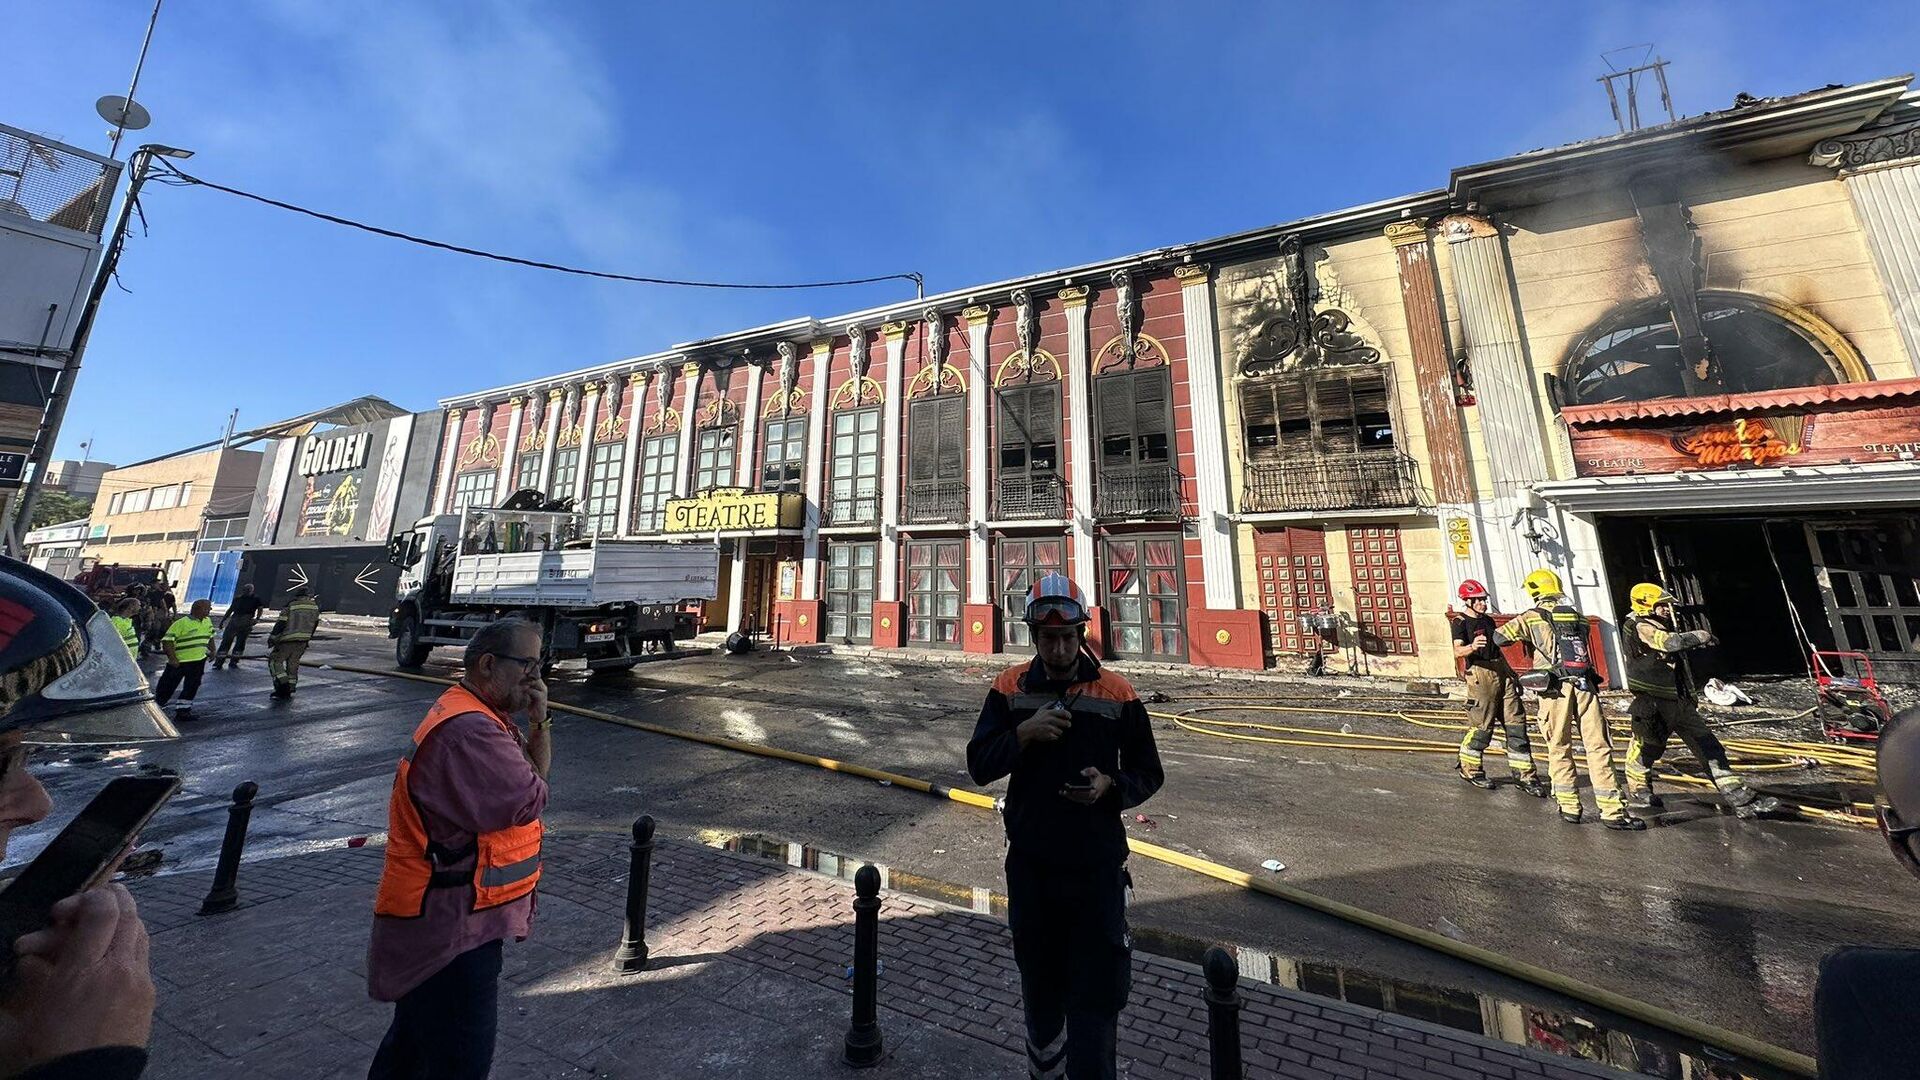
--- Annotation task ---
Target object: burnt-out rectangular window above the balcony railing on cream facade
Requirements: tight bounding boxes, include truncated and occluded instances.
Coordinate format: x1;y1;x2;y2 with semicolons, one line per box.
1240;367;1394;459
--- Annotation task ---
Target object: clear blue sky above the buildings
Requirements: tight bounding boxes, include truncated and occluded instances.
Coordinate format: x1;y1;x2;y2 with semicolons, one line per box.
11;0;1920;461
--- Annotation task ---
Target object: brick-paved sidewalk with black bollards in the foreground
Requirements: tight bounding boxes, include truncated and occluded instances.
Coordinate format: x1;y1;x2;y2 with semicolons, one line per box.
129;834;1624;1080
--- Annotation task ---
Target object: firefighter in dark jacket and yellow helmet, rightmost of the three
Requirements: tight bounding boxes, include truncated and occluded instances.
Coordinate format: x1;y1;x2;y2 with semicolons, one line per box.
1620;582;1780;817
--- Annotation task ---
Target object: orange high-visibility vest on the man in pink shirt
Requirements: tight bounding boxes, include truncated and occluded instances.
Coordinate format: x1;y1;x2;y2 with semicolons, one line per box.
372;686;541;919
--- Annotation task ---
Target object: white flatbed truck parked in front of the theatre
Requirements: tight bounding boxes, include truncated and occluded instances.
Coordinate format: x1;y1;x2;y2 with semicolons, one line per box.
388;507;720;671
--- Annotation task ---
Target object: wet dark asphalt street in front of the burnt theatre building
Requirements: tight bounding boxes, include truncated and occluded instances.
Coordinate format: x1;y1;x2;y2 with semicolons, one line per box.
13;628;1920;1051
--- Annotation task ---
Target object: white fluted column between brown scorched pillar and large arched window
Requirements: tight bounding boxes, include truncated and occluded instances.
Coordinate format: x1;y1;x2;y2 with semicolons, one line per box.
1440;213;1553;609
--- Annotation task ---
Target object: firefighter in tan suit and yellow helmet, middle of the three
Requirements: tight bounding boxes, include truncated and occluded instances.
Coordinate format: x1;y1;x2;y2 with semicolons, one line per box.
1498;569;1647;832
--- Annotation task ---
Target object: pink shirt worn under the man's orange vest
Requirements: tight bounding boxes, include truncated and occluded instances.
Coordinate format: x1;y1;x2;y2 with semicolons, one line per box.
367;713;547;1001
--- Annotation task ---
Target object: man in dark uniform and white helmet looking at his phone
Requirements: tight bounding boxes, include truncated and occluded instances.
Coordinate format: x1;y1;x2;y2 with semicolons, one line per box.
966;575;1165;1080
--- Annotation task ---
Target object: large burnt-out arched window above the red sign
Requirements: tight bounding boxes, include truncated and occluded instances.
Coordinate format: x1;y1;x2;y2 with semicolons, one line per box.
1565;288;1868;405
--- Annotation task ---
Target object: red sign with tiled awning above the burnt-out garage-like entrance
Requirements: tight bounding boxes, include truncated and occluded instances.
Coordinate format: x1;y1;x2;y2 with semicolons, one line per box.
1561;379;1920;477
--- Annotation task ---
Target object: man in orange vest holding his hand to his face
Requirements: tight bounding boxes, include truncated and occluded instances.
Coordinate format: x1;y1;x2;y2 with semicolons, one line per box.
367;619;553;1080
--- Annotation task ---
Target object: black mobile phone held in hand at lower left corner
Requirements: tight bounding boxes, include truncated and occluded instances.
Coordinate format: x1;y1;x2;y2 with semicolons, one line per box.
0;776;180;984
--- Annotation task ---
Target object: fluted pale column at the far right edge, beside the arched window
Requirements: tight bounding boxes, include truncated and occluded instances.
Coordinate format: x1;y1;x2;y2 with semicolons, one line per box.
1809;121;1920;373
